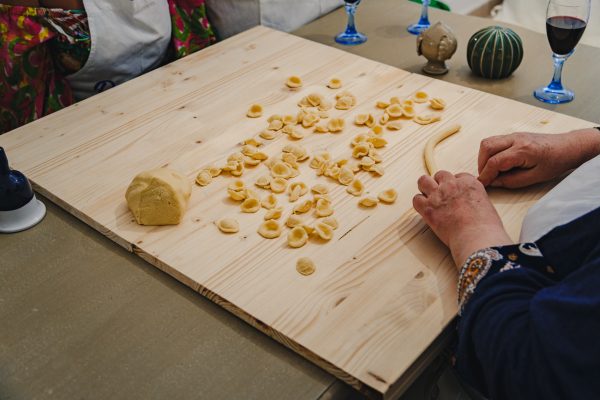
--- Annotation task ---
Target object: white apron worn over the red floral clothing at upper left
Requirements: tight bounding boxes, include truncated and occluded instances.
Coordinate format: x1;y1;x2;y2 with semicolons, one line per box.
66;0;171;100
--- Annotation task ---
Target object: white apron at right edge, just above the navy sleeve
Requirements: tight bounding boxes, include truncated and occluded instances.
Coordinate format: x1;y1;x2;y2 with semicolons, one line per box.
520;156;600;242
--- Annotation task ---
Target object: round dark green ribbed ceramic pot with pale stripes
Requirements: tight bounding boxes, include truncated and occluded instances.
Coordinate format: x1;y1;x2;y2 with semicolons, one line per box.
467;26;523;79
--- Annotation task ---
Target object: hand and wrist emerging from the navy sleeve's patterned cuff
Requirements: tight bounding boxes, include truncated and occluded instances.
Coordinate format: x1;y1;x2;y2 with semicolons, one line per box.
413;171;512;266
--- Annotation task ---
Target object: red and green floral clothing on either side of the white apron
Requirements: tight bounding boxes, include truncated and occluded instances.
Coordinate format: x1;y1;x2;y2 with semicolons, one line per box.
0;0;215;134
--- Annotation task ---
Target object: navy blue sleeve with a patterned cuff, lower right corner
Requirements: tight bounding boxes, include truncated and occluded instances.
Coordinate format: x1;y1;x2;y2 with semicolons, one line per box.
456;244;600;400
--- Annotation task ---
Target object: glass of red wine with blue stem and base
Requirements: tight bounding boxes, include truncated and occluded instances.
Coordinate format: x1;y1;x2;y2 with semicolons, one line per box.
533;0;591;104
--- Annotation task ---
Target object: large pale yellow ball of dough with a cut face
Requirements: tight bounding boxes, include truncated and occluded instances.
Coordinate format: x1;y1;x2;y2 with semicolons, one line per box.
125;168;192;225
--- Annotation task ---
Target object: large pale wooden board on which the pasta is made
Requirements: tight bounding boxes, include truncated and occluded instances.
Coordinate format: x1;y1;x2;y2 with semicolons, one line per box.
0;27;592;398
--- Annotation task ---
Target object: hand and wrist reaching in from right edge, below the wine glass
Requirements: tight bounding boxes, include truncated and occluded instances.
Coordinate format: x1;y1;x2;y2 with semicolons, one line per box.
478;129;600;188
